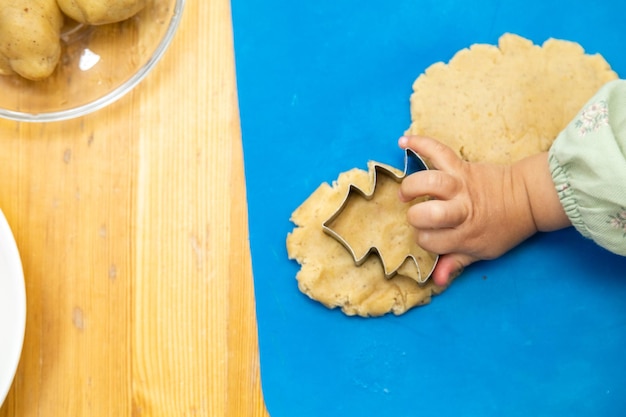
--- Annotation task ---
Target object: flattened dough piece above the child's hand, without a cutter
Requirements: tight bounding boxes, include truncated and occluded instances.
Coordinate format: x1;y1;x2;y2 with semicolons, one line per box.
405;33;617;163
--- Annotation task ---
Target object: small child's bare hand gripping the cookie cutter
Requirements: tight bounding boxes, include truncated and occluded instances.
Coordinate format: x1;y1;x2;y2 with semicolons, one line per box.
399;137;569;285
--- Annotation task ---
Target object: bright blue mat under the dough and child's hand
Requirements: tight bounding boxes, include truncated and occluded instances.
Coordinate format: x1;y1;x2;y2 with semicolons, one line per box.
232;0;626;417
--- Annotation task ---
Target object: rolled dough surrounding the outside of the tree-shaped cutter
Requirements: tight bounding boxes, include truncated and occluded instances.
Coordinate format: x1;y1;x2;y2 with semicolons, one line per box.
287;163;443;317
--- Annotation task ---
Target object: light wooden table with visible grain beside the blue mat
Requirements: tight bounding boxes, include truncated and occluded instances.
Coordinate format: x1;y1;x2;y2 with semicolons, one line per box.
0;0;267;417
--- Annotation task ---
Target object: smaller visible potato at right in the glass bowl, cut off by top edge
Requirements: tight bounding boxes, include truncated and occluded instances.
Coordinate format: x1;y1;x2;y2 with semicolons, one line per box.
57;0;147;25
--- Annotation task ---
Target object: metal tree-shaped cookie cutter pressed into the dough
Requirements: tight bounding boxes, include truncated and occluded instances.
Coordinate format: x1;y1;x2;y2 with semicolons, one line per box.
322;149;439;284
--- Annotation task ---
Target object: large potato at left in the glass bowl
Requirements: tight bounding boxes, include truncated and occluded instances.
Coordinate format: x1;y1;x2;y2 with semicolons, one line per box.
0;0;63;80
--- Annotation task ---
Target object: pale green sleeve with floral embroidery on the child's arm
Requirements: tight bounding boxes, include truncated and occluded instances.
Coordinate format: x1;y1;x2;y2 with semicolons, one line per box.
549;80;626;256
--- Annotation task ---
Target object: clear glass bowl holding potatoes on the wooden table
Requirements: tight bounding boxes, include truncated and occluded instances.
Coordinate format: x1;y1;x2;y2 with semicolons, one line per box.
0;0;185;122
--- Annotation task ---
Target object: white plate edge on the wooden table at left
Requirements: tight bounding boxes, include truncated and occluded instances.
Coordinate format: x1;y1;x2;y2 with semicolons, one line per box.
0;210;26;405
